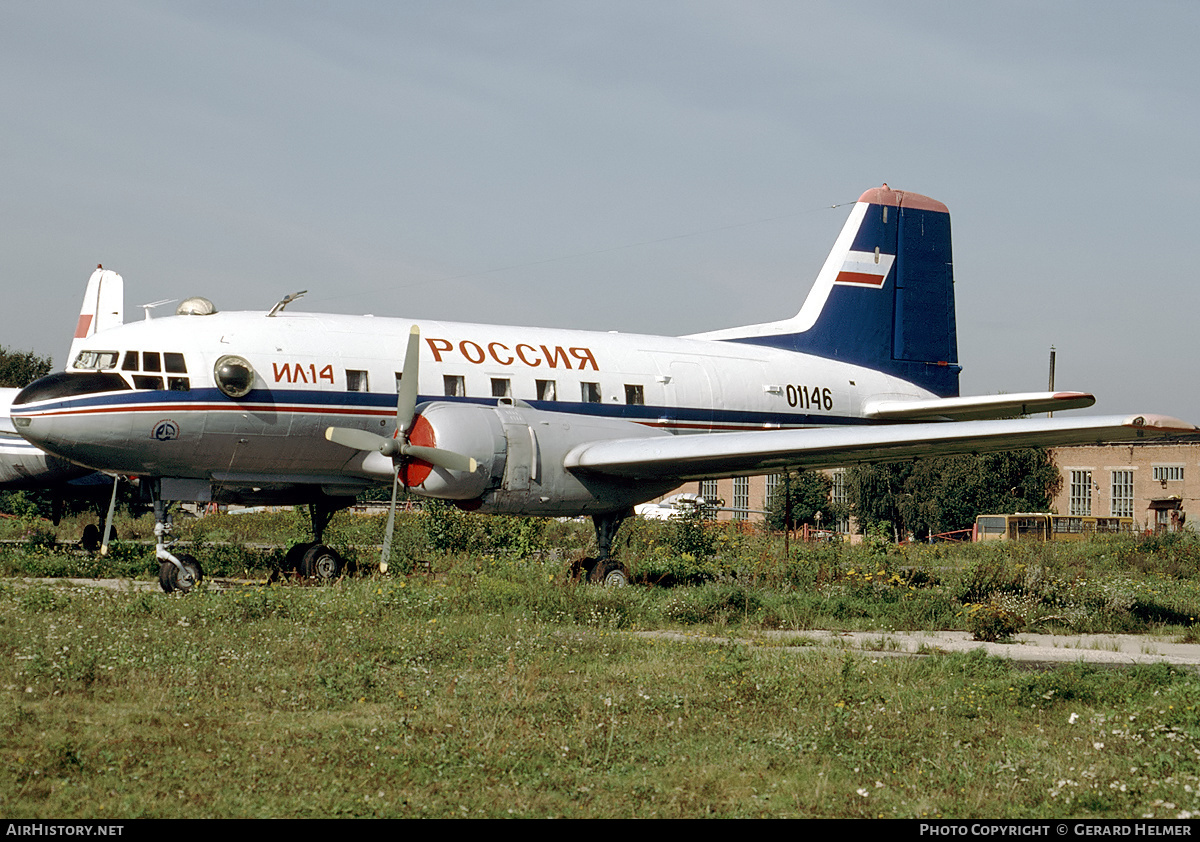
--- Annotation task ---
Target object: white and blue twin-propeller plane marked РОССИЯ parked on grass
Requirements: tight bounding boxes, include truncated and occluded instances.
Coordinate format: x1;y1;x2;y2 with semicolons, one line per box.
12;185;1196;591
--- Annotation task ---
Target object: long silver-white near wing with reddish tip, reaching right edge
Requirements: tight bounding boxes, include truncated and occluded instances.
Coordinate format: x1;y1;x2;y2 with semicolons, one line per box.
564;415;1200;482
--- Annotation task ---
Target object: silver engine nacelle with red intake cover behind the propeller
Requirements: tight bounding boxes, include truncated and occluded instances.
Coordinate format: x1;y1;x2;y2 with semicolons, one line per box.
362;403;674;516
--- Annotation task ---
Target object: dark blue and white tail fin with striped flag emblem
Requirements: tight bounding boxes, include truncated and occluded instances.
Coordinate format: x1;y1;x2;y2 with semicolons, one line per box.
696;185;960;397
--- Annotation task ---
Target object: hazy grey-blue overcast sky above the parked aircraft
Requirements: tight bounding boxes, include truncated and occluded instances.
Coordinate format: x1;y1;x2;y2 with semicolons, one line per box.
0;0;1200;422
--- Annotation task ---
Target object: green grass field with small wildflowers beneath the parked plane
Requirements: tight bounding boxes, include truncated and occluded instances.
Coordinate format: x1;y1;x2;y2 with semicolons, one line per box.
0;510;1200;818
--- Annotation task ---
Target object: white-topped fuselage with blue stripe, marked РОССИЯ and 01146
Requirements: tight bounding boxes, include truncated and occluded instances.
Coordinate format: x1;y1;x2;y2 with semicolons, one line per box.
14;312;935;513
